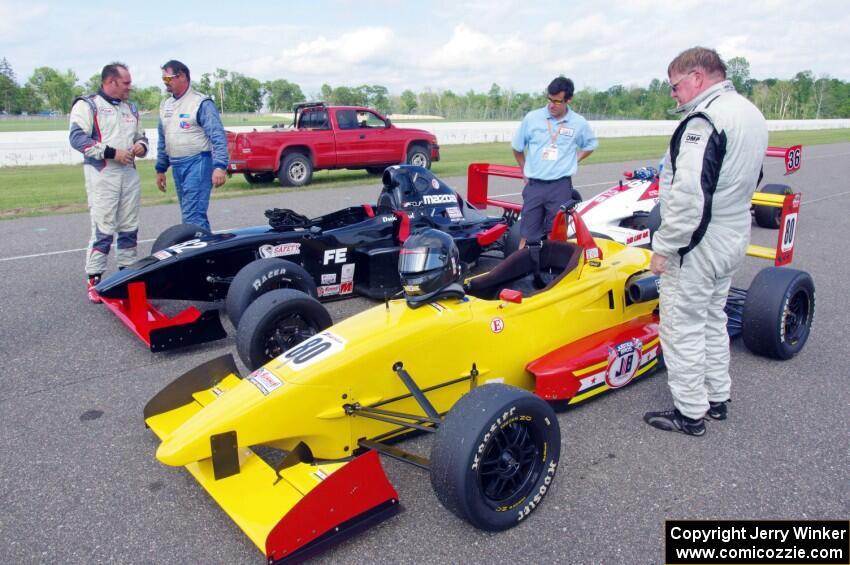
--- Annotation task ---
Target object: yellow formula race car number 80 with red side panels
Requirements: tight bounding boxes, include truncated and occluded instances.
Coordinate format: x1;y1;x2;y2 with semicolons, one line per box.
144;195;814;563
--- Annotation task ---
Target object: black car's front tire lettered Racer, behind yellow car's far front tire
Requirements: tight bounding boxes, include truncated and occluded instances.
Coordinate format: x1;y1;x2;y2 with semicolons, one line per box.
224;257;318;328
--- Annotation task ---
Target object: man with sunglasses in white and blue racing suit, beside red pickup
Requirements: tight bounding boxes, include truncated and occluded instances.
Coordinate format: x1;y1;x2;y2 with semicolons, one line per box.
156;60;229;230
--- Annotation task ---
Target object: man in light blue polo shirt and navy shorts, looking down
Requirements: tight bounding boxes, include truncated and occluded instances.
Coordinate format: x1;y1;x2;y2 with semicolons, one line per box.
511;76;599;248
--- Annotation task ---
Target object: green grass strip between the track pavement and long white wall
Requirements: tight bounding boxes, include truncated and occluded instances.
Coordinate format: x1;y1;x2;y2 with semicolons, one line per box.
0;129;850;219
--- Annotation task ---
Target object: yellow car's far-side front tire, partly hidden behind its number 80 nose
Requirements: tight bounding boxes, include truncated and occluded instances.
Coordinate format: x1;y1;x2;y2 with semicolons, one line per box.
236;288;333;371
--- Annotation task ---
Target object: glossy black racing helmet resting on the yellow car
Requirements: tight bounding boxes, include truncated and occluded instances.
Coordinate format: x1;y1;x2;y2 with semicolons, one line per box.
398;229;464;308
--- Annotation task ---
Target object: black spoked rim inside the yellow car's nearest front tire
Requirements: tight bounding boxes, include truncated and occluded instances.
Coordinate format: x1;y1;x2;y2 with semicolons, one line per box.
478;422;543;508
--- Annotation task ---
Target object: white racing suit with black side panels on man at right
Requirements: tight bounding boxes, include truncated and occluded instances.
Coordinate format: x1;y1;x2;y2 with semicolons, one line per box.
652;81;767;419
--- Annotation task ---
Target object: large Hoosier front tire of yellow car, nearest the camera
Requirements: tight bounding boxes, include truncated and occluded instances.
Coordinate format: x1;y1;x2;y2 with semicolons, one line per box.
431;384;561;531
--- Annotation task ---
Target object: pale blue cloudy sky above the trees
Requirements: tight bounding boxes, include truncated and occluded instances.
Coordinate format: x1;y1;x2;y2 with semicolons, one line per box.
0;0;850;96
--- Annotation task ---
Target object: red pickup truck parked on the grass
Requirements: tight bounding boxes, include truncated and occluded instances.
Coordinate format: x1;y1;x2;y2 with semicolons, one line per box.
227;103;440;186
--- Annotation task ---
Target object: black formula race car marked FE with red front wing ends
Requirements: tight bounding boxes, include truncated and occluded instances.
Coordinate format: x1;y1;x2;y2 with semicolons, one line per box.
97;165;512;351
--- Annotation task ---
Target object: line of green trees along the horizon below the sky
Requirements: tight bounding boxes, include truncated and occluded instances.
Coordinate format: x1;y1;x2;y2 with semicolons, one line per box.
0;57;850;120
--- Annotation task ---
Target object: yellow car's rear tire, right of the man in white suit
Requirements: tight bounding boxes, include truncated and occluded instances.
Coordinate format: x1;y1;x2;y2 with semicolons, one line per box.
742;267;815;360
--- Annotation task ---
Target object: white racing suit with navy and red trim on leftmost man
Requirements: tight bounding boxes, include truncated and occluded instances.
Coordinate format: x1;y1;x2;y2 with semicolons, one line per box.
69;90;148;276
